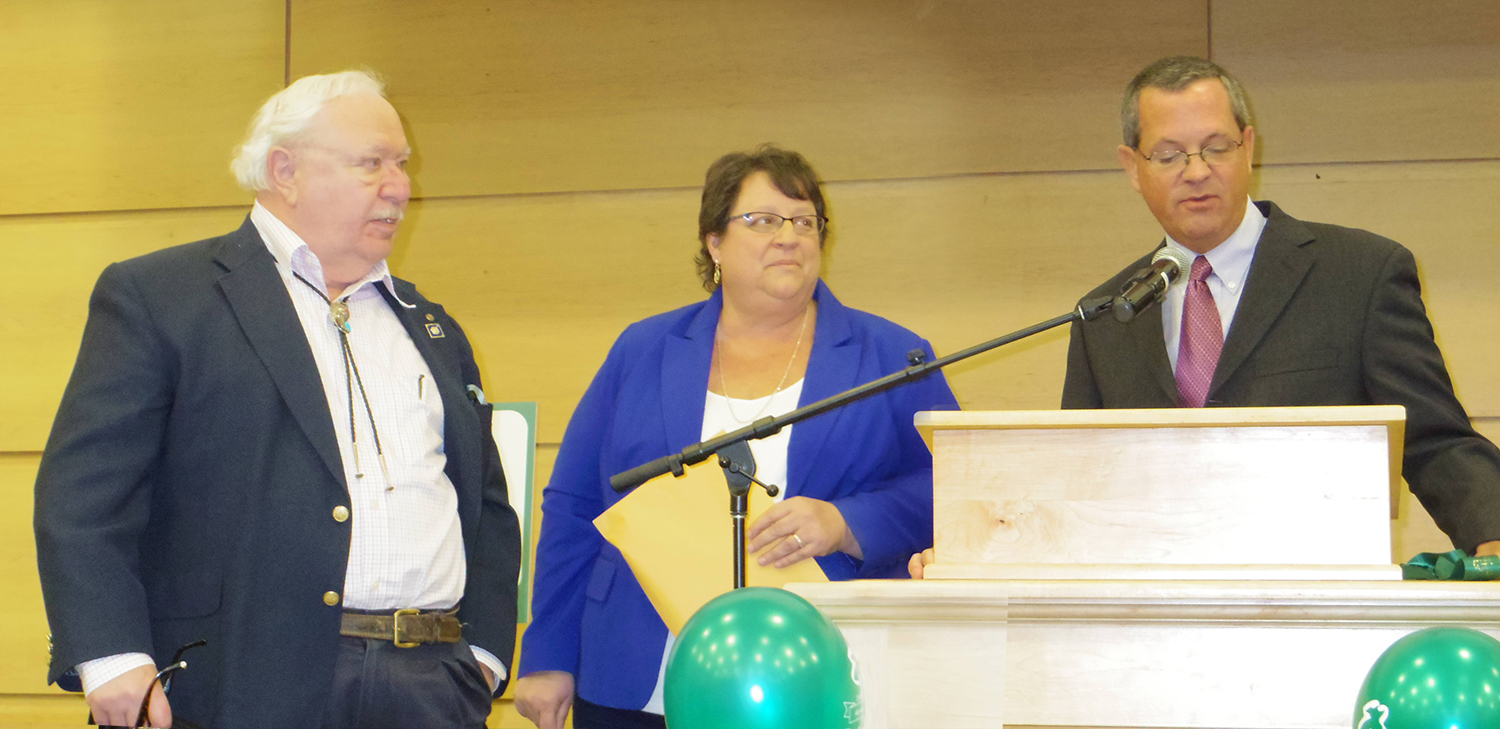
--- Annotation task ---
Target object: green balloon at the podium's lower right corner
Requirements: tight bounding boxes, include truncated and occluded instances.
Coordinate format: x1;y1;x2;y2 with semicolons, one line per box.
1355;627;1500;729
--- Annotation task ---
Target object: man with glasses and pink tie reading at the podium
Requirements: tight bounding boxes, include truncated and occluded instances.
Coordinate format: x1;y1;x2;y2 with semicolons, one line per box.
1062;57;1500;554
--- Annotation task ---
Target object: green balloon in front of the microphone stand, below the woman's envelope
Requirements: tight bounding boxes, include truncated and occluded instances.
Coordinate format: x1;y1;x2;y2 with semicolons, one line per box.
665;587;864;729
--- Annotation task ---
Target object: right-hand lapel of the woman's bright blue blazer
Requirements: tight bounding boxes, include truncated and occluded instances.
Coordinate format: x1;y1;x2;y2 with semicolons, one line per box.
786;281;860;497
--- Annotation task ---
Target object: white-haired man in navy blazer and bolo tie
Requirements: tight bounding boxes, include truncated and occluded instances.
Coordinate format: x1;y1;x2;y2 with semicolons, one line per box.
36;72;521;728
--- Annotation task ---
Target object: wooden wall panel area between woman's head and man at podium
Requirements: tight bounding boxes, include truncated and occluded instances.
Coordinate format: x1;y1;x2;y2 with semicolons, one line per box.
810;173;1161;410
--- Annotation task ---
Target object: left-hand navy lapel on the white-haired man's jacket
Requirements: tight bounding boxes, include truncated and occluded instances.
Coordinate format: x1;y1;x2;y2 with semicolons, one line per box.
216;216;348;489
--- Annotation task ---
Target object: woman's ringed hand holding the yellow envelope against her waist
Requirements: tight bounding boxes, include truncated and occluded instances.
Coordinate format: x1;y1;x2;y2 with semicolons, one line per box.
747;497;864;570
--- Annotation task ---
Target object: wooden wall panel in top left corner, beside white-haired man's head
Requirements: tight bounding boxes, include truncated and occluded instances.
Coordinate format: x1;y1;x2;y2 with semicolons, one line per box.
0;0;287;216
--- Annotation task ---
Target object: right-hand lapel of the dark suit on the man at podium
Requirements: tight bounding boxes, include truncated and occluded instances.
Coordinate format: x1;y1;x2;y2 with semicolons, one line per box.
1209;203;1314;401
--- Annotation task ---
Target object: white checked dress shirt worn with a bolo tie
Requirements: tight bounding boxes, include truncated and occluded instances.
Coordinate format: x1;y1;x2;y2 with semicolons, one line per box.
78;203;506;693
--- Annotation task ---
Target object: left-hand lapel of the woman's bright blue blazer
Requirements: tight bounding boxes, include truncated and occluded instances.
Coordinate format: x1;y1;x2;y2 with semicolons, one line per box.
660;291;725;453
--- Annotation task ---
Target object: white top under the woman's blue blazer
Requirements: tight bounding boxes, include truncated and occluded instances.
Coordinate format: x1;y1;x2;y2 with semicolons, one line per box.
641;378;806;714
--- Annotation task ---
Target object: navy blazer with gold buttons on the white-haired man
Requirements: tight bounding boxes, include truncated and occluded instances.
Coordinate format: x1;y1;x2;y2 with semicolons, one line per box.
35;218;521;728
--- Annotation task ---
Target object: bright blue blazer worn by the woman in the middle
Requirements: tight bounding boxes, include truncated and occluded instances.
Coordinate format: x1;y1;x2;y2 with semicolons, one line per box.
519;282;959;710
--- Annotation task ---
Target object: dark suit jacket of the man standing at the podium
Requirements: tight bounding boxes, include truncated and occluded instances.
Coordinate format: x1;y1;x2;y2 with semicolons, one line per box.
1062;203;1500;551
